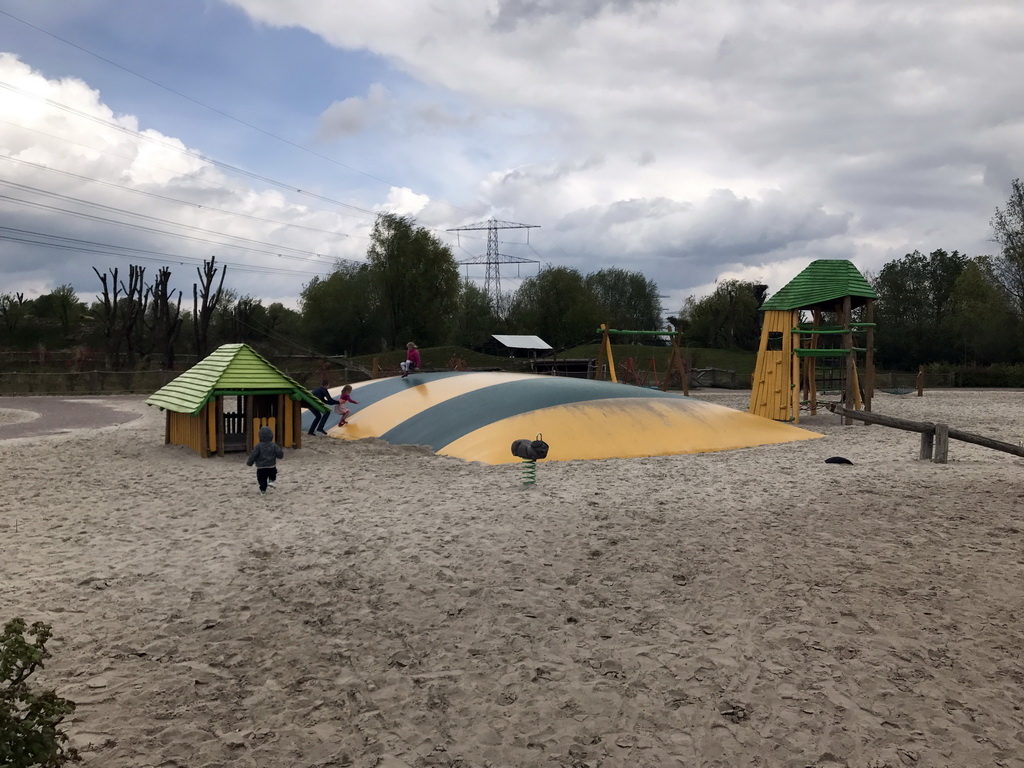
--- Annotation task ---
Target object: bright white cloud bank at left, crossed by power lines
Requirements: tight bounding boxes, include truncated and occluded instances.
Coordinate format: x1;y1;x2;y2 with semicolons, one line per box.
0;54;360;301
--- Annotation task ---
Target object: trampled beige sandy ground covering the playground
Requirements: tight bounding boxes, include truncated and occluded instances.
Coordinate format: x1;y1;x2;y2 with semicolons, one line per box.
0;391;1024;768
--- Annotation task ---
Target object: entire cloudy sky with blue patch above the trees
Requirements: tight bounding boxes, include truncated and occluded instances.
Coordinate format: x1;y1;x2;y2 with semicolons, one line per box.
0;0;1024;310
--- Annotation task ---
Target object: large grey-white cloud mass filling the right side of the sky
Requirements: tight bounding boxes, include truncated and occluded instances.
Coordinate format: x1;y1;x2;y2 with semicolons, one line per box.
232;0;1024;290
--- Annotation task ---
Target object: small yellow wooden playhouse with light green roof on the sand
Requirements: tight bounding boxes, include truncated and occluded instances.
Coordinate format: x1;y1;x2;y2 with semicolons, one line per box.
145;344;328;458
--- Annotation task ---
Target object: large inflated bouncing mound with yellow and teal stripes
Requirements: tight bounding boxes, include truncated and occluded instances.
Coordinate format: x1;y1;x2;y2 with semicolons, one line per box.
306;373;821;464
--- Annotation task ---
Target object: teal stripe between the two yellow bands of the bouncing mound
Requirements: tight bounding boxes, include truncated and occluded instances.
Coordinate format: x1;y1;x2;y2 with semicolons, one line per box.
381;376;683;451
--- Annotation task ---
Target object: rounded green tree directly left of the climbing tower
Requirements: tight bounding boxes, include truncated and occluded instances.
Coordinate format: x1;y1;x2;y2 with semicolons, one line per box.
676;280;767;349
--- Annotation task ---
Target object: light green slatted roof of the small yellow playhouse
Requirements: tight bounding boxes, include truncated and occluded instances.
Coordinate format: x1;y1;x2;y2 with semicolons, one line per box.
145;344;328;416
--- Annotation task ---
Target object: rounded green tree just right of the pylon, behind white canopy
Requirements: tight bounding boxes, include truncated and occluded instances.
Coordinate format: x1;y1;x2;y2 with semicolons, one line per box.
509;266;604;348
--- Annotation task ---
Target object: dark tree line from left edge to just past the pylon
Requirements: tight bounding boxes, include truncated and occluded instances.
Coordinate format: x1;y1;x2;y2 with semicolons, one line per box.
0;208;662;370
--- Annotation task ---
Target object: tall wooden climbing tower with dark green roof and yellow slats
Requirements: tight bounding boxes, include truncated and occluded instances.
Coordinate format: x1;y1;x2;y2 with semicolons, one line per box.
750;259;878;424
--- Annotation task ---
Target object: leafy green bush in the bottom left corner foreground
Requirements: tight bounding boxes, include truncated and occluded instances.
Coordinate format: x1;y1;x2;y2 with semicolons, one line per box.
0;618;81;768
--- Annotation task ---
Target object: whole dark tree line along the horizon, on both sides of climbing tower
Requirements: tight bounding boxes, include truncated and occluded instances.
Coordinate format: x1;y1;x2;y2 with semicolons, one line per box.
8;179;1024;383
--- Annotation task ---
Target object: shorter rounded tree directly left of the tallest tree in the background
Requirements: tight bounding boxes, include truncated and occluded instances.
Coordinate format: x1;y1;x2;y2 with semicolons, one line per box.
299;262;383;354
